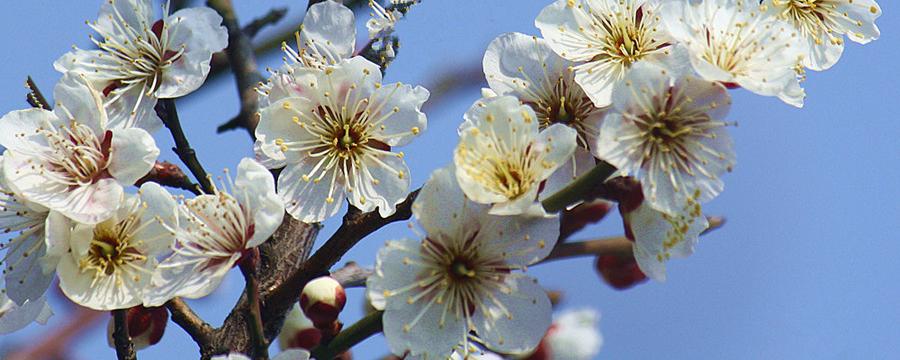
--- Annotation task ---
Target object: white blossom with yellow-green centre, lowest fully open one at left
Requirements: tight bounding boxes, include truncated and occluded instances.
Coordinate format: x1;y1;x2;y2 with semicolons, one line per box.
47;182;175;311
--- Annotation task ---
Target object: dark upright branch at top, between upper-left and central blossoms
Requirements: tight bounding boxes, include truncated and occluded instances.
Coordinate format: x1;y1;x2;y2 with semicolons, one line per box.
206;0;264;139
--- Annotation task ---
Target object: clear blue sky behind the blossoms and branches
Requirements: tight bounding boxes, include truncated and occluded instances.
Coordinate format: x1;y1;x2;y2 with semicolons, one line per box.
0;0;900;359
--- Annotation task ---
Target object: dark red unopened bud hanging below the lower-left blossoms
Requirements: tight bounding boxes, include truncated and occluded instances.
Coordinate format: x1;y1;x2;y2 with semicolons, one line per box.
106;305;169;350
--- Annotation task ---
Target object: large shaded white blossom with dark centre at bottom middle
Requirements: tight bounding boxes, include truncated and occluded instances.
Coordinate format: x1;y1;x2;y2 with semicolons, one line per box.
366;166;559;359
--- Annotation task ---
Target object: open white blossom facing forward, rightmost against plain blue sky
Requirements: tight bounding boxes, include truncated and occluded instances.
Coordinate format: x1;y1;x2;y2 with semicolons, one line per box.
595;64;735;214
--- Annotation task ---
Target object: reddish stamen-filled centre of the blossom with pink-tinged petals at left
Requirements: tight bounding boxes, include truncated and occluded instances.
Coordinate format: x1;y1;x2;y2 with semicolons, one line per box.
38;121;112;187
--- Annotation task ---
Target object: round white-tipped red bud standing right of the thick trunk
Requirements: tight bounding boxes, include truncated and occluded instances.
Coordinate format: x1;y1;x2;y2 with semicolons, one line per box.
300;276;347;329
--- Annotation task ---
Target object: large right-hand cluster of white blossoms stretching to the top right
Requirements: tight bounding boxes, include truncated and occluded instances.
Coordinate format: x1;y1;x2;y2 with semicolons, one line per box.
358;0;880;359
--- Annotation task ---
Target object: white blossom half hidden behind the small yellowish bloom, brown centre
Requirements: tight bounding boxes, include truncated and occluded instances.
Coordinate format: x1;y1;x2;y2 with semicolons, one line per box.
483;33;605;194
